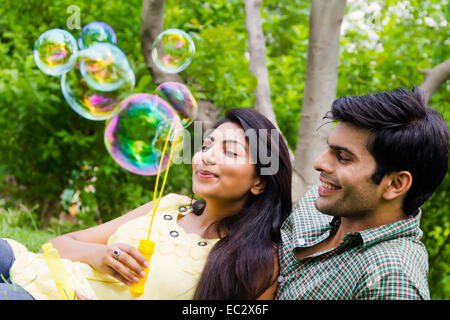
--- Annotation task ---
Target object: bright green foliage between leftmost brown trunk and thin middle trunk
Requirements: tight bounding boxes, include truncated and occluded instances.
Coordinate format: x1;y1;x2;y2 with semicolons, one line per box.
164;0;257;110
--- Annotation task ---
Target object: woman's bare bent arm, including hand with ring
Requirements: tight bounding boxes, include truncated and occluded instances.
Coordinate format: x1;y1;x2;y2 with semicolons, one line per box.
43;202;152;285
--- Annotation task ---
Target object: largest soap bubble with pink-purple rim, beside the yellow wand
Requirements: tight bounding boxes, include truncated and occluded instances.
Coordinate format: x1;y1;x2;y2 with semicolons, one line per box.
104;93;183;176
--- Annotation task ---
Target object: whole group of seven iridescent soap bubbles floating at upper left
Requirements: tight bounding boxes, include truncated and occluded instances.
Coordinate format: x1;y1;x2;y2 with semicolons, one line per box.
33;21;198;175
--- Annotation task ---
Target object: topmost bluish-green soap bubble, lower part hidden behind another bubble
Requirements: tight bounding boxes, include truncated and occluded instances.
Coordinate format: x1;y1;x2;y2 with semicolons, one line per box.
78;21;117;50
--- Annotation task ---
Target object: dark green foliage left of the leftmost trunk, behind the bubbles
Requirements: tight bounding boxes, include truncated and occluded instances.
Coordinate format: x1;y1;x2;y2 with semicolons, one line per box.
0;1;190;225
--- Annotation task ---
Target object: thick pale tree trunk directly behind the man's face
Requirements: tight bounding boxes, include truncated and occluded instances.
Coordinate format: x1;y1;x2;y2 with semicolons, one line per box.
292;0;346;201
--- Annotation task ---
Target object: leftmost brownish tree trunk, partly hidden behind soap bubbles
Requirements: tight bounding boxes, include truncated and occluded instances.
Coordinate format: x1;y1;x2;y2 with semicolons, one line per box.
140;0;220;128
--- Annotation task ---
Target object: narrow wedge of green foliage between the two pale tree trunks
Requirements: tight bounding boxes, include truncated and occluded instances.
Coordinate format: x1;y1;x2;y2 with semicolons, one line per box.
262;0;309;150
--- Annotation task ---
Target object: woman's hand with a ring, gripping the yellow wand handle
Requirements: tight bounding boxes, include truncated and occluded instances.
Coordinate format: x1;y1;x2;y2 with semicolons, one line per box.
90;243;148;286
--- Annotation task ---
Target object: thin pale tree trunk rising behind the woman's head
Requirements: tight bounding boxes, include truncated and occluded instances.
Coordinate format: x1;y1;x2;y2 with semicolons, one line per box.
244;0;278;127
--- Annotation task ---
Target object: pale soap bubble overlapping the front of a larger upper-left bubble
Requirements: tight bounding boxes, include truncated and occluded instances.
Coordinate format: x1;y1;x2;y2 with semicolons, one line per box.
79;42;135;91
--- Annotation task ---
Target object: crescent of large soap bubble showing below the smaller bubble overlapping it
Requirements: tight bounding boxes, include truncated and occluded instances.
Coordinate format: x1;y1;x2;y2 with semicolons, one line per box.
61;56;134;120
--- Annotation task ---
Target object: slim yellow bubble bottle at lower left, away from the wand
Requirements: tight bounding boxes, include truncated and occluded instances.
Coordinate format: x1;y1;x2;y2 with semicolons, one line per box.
42;243;77;300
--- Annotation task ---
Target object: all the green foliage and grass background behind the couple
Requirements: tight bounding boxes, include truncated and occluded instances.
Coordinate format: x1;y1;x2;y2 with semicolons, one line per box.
0;0;450;299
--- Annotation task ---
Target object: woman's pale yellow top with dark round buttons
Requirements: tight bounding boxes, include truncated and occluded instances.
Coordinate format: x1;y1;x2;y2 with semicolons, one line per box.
5;193;218;300
